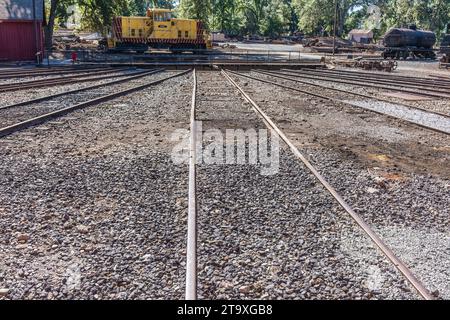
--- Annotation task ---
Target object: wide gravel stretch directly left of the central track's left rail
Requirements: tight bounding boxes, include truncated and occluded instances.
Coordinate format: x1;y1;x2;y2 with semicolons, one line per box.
0;71;192;299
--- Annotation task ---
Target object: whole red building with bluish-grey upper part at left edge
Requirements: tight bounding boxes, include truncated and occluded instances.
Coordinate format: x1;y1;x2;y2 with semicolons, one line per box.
0;0;44;62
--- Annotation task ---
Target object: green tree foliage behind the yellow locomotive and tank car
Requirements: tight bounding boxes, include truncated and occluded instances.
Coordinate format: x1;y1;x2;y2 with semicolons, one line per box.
46;0;450;37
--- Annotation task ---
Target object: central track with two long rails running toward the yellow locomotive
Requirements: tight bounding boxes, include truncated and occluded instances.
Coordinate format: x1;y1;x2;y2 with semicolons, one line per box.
186;70;433;300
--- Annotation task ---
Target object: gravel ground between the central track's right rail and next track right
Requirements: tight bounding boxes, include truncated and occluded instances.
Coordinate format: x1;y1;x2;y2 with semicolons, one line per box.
229;73;450;299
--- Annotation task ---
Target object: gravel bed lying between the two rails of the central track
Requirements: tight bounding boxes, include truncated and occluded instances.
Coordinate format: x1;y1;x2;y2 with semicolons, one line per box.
198;70;417;299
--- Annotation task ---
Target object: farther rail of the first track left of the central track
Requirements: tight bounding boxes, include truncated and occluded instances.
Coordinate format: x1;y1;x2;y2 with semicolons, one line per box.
0;68;164;110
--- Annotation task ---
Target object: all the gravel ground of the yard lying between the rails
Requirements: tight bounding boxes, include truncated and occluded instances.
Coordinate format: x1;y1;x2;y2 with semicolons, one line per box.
0;66;450;300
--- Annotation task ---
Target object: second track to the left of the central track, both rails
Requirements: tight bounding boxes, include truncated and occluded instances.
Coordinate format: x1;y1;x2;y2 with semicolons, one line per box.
0;68;133;93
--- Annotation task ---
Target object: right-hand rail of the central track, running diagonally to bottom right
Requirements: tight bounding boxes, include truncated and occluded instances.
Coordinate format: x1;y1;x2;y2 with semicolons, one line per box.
222;70;433;300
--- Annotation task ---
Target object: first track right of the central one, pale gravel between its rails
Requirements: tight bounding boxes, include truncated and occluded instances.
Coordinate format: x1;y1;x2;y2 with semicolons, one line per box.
235;71;450;135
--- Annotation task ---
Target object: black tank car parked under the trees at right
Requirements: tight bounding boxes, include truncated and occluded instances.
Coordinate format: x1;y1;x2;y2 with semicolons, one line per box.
383;26;436;60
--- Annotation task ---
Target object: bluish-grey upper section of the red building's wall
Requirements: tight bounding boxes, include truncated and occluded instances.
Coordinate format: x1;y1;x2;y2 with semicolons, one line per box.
0;0;44;21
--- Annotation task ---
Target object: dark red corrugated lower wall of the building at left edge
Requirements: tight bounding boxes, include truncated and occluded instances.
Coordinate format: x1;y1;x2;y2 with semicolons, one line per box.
0;20;44;61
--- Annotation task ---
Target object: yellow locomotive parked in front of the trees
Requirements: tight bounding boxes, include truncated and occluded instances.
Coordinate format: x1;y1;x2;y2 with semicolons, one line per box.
108;8;211;53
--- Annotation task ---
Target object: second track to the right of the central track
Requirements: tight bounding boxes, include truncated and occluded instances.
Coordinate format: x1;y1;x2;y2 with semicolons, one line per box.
281;69;450;93
